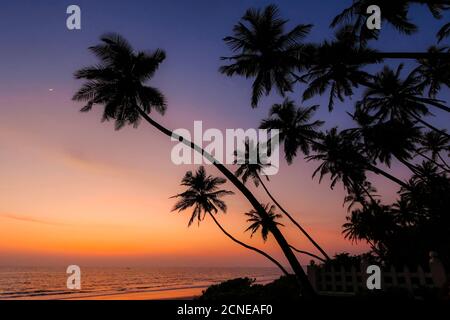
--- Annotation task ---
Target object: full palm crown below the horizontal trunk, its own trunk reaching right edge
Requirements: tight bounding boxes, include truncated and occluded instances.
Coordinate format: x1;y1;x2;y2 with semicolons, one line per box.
357;65;450;134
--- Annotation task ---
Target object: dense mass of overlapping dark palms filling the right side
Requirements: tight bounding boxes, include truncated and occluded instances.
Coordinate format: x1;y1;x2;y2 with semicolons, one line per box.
220;4;450;268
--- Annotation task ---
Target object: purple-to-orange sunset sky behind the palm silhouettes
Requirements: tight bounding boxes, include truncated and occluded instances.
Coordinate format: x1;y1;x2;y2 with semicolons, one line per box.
0;0;450;266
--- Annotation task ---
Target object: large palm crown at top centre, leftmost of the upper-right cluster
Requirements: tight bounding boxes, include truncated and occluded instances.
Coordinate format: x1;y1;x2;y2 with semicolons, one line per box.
220;5;312;107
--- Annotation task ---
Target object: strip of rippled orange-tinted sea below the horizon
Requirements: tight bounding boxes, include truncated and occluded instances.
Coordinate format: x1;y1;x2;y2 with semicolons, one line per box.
0;267;281;299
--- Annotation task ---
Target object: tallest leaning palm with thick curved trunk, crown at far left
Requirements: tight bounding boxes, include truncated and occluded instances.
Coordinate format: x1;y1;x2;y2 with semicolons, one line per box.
73;34;315;296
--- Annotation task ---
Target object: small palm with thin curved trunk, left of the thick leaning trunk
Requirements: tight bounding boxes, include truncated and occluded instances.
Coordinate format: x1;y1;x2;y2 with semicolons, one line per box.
172;166;288;275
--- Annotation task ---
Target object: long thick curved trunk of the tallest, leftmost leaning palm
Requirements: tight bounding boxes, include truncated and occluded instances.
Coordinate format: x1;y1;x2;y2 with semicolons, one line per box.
136;106;316;297
